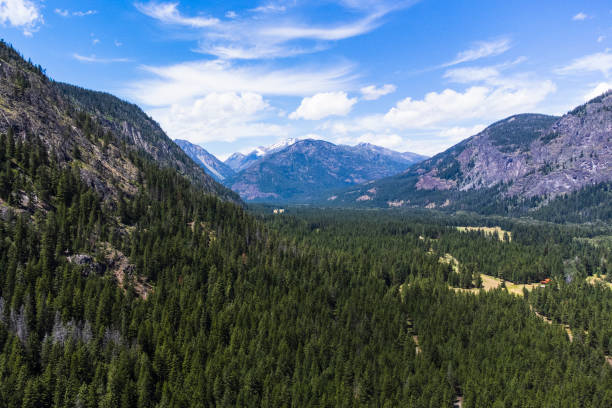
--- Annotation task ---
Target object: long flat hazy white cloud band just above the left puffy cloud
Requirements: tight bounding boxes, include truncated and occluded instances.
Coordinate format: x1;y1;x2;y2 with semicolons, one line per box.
126;60;355;106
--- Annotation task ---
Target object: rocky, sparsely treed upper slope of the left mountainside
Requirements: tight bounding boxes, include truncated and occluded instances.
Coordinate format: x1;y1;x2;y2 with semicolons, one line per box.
0;43;237;204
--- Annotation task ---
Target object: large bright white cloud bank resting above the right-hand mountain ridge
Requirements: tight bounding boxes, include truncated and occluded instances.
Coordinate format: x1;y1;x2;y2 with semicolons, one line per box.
320;67;556;155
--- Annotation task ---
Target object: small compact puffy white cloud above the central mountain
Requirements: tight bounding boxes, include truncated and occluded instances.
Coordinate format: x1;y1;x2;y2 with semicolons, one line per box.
289;92;357;120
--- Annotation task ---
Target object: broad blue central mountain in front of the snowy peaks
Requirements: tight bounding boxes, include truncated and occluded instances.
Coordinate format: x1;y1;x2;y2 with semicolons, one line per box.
226;140;423;201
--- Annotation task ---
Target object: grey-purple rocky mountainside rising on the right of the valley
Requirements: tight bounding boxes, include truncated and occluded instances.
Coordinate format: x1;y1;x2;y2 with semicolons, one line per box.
337;92;612;209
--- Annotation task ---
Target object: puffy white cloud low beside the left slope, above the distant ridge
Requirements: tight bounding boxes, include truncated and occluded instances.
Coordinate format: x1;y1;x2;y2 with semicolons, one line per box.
149;92;287;143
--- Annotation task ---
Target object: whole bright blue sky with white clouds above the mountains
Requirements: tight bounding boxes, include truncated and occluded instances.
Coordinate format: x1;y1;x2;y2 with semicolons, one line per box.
0;0;612;158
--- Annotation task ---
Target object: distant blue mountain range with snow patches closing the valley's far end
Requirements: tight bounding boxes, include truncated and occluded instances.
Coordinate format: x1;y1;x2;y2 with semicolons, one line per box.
176;139;426;202
